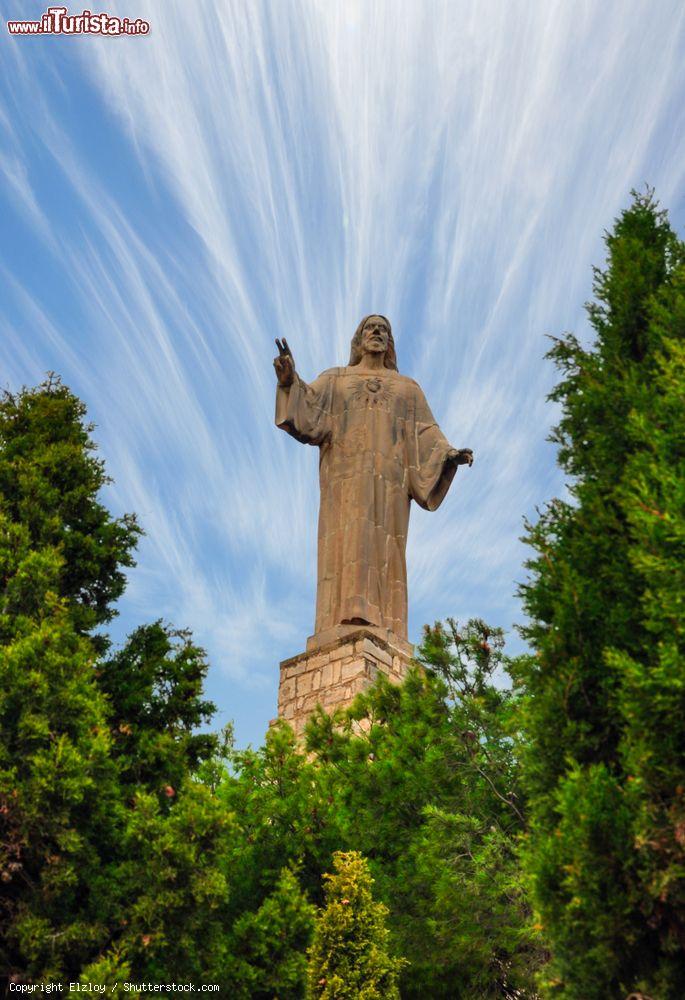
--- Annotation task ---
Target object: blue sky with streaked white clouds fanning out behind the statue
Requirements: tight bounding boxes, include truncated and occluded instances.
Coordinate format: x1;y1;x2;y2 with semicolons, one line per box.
0;0;685;744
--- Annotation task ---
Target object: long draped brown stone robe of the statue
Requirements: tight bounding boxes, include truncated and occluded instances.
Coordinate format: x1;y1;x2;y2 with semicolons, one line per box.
276;367;456;639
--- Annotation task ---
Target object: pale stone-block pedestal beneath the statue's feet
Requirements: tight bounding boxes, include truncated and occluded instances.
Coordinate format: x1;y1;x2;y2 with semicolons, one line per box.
278;625;414;737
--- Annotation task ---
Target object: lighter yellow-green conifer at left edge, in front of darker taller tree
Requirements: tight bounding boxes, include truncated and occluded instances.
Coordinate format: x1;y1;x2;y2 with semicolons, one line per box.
0;513;122;981
